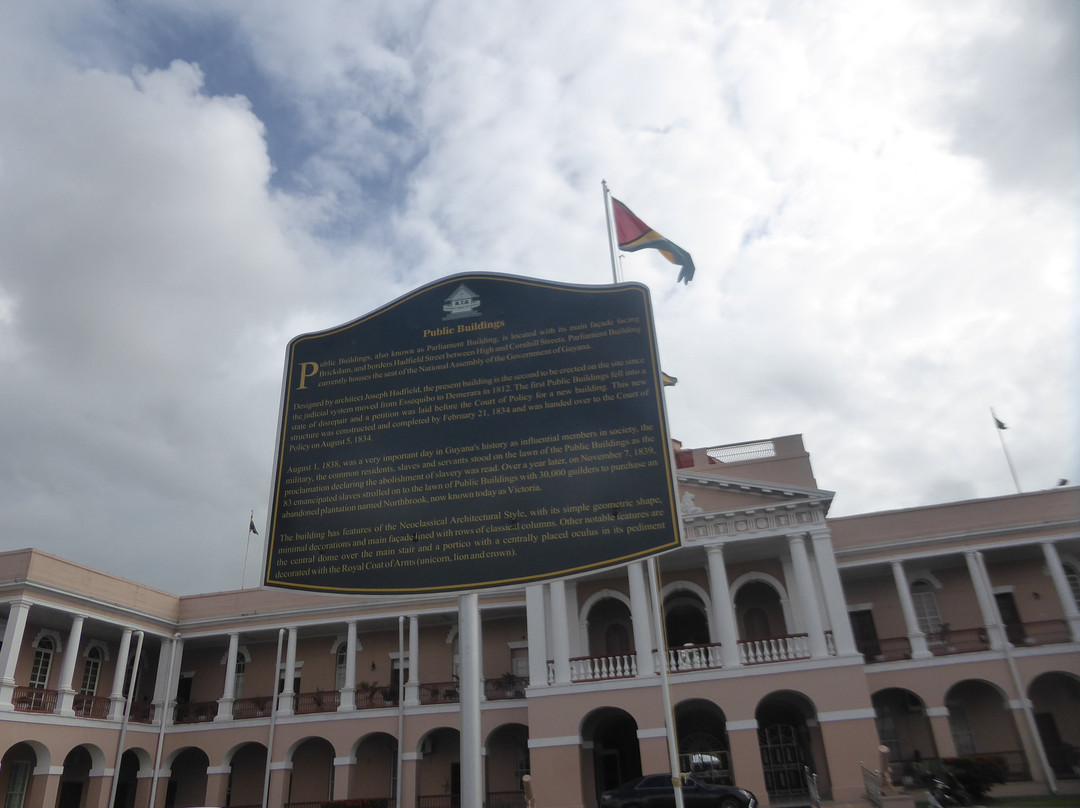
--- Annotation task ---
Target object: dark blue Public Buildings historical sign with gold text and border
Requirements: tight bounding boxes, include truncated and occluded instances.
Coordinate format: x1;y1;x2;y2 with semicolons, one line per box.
265;274;678;593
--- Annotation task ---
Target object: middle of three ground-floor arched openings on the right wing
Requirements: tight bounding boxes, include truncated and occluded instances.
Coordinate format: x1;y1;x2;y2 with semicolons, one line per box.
945;679;1030;780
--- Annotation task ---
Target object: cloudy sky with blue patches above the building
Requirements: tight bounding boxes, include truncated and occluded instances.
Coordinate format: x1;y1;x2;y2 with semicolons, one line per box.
0;0;1080;594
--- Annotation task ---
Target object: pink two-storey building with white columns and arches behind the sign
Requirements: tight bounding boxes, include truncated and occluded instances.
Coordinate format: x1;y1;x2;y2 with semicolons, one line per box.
0;435;1080;808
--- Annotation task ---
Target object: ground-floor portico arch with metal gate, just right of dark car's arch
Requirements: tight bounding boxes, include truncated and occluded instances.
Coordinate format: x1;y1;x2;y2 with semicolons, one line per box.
754;690;832;802
